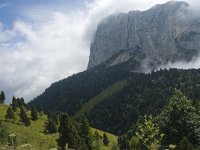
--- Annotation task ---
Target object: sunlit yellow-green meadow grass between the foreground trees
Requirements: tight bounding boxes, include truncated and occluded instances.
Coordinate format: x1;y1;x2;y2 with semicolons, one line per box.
0;99;117;150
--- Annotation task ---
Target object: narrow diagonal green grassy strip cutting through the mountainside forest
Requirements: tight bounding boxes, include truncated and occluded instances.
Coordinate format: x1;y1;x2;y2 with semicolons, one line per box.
73;80;127;119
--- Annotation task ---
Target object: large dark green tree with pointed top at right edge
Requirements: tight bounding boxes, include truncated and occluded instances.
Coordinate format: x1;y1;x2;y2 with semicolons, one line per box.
158;90;200;144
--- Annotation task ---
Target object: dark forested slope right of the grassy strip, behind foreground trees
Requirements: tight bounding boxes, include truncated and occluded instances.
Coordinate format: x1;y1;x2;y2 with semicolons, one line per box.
86;69;200;135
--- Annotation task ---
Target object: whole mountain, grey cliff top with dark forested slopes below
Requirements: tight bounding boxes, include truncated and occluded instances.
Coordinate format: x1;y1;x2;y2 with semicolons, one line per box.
28;1;200;135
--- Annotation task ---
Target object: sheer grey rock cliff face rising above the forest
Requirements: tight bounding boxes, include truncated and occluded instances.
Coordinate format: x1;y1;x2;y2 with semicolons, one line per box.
88;1;200;68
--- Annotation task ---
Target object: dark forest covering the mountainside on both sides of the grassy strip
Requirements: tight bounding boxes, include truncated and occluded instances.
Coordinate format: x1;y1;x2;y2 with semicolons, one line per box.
29;64;200;135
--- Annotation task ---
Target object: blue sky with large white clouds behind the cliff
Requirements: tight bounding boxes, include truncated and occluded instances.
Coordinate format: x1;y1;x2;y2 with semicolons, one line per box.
0;0;200;102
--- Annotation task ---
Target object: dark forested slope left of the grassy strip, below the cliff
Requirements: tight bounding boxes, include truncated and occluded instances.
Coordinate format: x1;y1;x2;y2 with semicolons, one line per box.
28;62;130;115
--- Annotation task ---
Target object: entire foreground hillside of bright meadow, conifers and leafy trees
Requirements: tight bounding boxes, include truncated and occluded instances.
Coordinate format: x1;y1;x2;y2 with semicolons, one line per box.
0;89;200;150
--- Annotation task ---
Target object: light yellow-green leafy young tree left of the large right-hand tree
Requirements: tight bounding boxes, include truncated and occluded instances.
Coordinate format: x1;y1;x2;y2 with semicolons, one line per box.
135;115;164;149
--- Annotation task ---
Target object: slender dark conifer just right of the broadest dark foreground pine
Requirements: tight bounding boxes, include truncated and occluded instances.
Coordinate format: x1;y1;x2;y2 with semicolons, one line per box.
79;115;93;150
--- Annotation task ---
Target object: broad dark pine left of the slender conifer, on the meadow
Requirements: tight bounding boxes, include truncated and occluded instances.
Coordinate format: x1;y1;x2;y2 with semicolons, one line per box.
57;113;78;150
